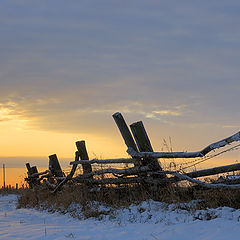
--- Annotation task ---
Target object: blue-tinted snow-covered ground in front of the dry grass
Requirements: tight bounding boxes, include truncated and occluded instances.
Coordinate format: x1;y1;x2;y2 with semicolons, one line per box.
0;195;240;240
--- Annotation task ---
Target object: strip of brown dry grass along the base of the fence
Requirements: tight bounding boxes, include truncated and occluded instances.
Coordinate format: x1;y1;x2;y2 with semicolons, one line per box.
18;180;240;218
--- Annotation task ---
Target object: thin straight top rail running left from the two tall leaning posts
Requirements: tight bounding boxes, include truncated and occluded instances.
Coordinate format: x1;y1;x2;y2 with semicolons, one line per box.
70;158;139;165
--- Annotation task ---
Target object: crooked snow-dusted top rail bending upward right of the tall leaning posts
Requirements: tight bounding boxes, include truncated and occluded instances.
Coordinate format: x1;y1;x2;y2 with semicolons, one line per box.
127;132;240;158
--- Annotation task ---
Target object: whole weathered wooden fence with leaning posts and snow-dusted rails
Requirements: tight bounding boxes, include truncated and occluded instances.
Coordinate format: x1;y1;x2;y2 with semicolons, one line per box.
25;112;240;193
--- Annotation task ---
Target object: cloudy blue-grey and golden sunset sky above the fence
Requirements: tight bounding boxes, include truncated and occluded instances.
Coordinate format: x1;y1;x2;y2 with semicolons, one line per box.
0;0;240;184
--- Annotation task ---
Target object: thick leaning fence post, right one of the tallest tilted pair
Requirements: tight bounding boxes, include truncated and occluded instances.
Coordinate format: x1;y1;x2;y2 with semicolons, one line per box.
130;121;162;170
